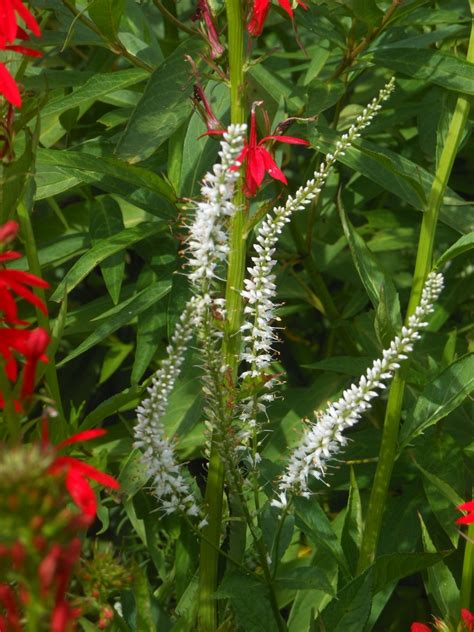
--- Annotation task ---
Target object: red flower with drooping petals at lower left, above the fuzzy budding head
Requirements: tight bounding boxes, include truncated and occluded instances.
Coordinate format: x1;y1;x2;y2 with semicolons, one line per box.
43;428;120;522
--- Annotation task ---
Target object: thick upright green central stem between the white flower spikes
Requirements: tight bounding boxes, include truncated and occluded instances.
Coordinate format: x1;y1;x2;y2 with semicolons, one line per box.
198;0;246;632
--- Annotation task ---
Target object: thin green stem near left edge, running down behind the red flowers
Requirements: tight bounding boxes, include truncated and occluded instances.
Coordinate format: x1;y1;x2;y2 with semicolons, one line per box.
17;201;64;419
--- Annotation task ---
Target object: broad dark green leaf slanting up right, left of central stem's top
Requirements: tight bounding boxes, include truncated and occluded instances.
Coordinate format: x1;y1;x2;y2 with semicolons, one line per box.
116;39;204;163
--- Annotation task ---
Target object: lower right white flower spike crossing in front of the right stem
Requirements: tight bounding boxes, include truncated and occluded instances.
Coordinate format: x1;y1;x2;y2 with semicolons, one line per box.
272;272;443;508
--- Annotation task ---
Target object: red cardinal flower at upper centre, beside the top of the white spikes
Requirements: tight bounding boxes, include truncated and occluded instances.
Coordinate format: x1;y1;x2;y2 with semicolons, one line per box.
237;104;309;197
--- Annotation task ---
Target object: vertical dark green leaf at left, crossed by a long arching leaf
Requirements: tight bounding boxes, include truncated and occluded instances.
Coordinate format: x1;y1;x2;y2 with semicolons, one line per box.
89;196;125;305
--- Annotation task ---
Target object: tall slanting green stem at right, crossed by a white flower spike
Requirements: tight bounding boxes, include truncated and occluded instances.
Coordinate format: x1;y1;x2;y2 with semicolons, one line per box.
358;22;474;573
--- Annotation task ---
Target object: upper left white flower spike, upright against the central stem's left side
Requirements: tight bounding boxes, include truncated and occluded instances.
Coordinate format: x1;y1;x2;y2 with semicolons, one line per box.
188;125;247;285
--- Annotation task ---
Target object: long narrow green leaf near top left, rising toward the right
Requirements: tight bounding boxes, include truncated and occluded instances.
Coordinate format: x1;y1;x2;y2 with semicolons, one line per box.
41;68;150;117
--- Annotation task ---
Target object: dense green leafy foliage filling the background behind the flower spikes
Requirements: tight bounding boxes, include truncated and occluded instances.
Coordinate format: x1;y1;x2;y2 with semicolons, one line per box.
0;0;474;632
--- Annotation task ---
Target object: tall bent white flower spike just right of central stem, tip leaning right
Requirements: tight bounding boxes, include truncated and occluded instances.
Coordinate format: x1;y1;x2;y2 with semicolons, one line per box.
241;79;395;377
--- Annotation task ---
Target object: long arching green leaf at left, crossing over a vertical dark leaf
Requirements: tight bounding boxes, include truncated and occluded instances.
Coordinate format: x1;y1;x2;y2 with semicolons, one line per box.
50;221;166;301
